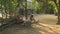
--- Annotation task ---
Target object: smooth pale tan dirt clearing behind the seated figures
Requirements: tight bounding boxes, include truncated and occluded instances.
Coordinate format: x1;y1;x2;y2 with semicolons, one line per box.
36;14;58;25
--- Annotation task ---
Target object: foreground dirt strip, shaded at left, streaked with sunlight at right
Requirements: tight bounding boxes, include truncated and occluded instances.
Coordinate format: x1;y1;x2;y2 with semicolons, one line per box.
0;23;60;34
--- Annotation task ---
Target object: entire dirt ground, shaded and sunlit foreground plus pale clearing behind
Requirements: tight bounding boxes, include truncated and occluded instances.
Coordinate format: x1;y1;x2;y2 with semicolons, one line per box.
0;15;60;34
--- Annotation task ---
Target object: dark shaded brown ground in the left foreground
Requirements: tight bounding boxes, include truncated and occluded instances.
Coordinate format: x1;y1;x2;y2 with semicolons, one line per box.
0;24;41;34
